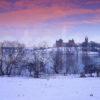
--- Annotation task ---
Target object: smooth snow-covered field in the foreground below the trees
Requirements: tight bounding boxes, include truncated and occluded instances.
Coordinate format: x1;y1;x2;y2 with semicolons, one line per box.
0;77;100;100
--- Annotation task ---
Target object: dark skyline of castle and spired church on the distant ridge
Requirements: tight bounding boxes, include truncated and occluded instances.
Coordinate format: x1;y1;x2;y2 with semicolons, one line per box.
56;37;100;52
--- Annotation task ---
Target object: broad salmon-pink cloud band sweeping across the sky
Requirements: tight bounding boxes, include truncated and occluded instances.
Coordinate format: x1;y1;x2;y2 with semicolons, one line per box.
0;7;100;27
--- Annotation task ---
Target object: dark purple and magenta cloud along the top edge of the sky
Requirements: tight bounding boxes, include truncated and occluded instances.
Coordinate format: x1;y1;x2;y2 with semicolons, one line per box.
0;0;100;13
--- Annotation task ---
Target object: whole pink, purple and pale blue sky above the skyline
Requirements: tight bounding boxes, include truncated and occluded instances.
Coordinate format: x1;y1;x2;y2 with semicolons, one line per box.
0;0;100;46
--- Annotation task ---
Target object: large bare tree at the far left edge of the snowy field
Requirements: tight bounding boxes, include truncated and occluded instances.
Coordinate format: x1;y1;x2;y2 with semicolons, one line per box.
0;42;23;76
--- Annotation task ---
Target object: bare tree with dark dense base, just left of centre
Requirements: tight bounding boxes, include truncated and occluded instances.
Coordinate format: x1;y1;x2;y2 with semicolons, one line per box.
28;45;47;78
